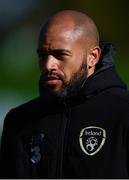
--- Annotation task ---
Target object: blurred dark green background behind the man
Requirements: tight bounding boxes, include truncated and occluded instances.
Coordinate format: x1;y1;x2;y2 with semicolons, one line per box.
0;0;129;138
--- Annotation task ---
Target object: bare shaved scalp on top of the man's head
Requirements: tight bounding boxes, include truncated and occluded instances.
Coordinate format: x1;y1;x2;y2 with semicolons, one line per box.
39;10;99;47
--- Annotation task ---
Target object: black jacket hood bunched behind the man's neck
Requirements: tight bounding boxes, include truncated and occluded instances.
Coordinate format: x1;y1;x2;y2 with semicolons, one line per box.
84;41;127;96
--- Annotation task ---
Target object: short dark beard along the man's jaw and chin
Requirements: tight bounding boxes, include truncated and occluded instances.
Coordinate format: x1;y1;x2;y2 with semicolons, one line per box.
39;60;87;100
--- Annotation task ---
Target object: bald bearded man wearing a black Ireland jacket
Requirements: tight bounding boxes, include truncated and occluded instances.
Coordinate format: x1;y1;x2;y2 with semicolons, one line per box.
0;10;129;178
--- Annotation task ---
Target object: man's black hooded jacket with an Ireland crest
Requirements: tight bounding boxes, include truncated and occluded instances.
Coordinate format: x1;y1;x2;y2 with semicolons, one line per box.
0;42;129;179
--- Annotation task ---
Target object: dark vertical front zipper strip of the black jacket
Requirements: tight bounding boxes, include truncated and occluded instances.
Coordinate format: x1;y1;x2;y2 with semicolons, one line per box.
56;101;71;179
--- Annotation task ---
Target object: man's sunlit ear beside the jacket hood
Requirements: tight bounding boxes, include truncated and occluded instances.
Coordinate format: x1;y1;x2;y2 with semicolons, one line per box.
87;46;101;69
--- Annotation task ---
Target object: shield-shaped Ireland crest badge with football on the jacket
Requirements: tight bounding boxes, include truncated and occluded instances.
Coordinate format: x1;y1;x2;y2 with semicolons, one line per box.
79;126;106;156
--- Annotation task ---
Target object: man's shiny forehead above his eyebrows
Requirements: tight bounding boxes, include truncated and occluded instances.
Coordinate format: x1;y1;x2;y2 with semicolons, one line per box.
39;24;83;47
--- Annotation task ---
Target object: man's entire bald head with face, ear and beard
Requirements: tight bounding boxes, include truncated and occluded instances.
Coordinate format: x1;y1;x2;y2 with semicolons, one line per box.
37;10;101;96
